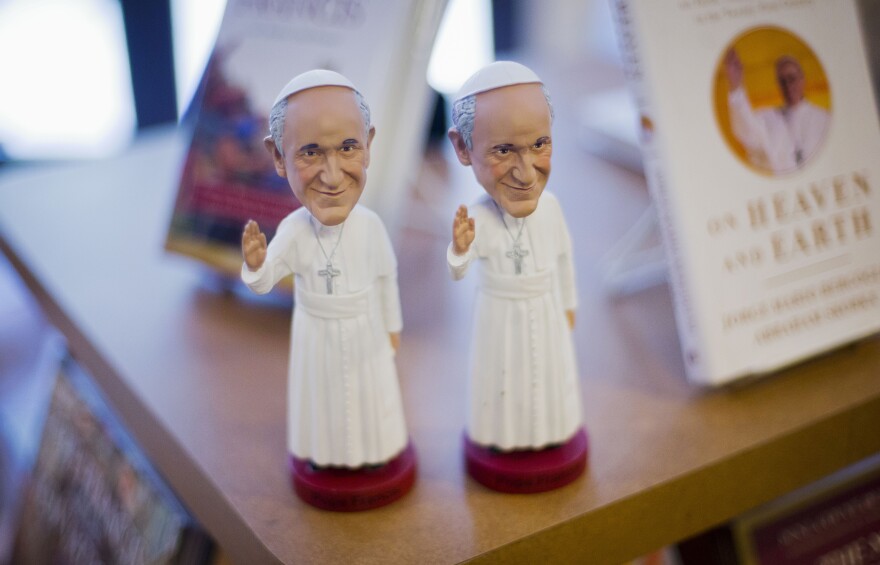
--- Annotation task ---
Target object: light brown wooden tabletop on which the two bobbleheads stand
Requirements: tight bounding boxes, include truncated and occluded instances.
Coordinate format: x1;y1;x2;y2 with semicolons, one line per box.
0;124;880;563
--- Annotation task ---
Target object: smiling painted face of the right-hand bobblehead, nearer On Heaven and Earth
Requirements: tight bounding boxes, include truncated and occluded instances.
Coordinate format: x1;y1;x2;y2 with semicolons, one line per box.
453;83;552;218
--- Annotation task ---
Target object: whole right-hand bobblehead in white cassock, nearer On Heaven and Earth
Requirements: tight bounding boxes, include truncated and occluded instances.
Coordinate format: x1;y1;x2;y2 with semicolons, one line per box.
447;61;586;492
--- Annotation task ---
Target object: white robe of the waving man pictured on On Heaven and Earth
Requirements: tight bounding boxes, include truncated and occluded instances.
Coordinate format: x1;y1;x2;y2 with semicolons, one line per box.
727;87;830;174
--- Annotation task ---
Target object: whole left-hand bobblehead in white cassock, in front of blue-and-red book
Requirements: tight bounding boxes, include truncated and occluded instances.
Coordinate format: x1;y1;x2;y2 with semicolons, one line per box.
241;70;414;510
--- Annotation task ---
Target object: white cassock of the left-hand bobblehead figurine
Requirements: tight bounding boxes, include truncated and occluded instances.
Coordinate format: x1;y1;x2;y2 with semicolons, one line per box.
241;206;407;467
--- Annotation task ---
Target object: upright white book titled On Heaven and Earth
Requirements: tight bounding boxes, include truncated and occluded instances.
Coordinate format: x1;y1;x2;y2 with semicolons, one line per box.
613;0;880;385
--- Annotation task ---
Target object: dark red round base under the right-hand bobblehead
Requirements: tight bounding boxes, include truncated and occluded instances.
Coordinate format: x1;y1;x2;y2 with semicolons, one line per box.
464;428;587;494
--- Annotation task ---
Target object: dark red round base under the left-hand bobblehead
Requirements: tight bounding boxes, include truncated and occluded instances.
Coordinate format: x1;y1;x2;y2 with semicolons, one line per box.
290;444;416;512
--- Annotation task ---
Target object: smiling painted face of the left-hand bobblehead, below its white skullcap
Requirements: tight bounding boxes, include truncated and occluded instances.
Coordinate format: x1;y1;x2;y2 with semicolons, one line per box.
266;86;376;226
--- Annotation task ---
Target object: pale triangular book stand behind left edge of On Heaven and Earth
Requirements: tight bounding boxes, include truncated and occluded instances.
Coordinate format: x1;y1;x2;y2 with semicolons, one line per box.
599;204;667;297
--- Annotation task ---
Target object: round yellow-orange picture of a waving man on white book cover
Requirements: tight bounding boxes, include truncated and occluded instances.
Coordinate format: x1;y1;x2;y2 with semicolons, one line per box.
713;26;832;177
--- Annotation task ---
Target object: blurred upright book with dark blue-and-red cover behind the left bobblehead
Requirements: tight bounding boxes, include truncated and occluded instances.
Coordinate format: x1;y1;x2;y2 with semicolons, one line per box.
165;0;445;275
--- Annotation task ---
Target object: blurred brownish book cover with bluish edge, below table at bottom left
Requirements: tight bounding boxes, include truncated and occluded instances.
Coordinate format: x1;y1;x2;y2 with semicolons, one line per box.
12;360;213;564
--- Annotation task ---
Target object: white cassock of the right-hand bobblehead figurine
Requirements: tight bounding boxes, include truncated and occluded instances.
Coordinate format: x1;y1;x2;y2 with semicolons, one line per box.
446;192;581;450
